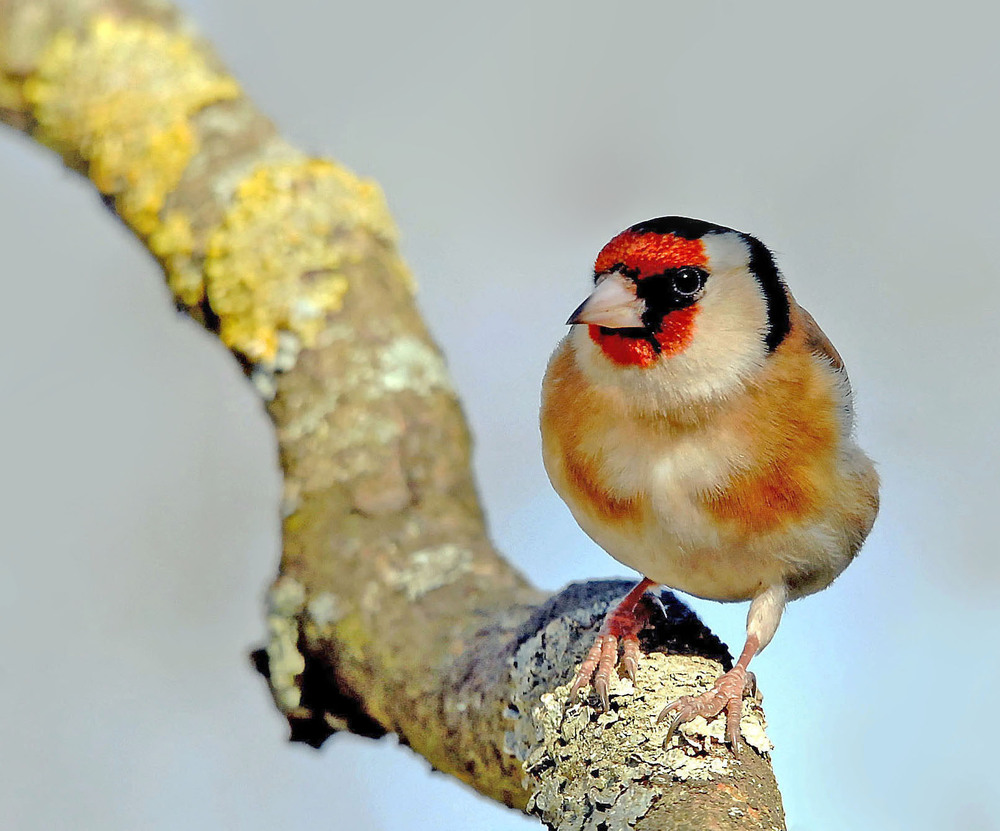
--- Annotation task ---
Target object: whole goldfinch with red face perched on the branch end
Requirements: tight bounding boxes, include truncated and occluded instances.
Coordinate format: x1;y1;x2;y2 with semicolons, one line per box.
540;216;879;751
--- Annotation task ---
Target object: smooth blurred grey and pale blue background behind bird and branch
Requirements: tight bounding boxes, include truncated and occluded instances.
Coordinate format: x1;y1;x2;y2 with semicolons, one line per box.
0;0;1000;831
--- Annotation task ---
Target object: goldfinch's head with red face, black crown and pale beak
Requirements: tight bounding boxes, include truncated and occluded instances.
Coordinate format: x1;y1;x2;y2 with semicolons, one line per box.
567;216;790;409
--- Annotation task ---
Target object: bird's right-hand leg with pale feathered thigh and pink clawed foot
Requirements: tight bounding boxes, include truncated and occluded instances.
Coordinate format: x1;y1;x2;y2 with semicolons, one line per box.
657;585;787;752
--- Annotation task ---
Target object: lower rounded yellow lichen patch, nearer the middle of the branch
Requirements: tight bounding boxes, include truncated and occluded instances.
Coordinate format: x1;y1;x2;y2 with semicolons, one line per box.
204;159;394;364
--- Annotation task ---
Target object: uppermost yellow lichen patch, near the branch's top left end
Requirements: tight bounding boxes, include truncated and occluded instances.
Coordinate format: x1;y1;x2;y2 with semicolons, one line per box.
23;16;240;237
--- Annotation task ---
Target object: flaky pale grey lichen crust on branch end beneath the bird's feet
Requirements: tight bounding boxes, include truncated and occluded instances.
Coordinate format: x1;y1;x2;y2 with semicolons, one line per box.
505;596;770;831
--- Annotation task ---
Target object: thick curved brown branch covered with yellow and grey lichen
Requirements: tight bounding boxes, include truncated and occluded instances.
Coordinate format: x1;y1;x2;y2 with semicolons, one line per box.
0;0;783;829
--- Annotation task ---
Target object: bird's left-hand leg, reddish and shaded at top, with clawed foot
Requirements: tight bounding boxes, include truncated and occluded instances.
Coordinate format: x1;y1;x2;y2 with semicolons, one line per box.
569;578;656;710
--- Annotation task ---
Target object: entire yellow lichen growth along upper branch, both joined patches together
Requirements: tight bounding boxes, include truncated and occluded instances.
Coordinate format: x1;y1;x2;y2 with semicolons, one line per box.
17;15;402;371
